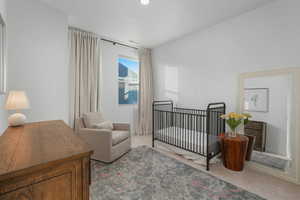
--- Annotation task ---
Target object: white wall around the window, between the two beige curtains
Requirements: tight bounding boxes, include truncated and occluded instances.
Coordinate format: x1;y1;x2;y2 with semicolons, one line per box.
101;42;138;133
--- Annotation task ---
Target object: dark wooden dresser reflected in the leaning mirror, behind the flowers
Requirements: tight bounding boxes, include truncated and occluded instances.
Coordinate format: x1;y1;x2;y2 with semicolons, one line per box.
245;121;267;152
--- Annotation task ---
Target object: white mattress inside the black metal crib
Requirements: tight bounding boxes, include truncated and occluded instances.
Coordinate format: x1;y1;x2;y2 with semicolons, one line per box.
155;126;219;155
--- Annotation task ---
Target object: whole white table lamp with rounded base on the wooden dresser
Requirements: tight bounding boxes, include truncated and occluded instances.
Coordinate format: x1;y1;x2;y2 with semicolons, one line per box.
5;91;29;126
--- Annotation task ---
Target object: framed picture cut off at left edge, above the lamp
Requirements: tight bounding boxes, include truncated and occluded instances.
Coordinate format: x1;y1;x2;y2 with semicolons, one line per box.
0;15;7;94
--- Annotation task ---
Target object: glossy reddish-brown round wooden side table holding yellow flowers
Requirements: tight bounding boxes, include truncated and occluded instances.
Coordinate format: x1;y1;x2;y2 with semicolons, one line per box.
220;134;249;171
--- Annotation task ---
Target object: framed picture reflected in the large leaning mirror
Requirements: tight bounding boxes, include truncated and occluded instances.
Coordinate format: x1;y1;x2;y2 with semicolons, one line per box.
244;88;269;113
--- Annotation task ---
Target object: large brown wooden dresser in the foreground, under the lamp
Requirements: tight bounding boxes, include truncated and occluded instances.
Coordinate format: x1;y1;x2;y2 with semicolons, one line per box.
0;121;92;200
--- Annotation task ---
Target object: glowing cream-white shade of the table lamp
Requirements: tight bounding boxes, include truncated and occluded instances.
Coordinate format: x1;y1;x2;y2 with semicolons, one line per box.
5;91;29;110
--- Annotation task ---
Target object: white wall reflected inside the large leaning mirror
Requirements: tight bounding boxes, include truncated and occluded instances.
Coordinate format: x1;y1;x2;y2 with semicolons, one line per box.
244;75;292;156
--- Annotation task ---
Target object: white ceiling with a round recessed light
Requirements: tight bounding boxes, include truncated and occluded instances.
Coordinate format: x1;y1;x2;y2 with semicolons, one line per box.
41;0;273;47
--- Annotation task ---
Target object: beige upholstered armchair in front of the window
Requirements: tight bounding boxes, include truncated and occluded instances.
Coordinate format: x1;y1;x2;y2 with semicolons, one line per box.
76;113;131;163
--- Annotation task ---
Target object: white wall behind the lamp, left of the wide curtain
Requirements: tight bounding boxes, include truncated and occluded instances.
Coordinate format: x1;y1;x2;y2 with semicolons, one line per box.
7;0;69;126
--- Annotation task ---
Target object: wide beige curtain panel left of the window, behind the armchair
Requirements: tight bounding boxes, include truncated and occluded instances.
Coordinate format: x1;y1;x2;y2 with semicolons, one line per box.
69;28;100;127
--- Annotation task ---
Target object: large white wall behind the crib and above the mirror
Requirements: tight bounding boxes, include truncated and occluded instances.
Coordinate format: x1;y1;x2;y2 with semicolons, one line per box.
153;0;300;111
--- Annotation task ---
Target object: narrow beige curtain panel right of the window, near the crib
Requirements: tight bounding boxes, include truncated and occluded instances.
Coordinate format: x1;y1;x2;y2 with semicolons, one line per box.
136;49;153;136
